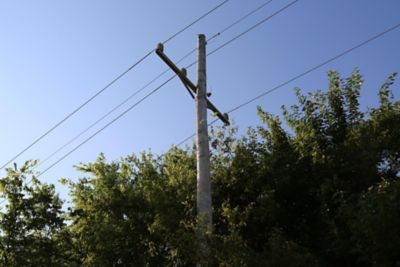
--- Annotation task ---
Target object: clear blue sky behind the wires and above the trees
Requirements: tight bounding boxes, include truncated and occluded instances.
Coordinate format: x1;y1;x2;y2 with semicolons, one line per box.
0;0;400;203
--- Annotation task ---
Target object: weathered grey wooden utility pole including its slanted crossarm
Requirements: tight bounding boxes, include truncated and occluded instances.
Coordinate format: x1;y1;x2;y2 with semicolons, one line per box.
156;34;229;266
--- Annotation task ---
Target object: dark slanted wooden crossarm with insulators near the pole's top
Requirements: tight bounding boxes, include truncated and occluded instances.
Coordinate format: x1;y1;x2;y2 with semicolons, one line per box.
156;43;229;125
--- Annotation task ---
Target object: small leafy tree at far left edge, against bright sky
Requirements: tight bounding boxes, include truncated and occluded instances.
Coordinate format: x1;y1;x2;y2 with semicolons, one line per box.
0;161;74;266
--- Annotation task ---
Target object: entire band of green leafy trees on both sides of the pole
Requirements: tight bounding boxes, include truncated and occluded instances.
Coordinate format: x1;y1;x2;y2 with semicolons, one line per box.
0;70;400;267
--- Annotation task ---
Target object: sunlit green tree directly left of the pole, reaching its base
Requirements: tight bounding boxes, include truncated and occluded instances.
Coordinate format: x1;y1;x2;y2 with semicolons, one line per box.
70;152;200;266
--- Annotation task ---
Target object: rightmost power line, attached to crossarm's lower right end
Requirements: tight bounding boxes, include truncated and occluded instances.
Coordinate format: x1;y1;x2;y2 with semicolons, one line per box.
176;23;400;146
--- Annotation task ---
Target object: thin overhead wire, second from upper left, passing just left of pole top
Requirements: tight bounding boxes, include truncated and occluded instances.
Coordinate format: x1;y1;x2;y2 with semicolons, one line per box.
35;0;273;168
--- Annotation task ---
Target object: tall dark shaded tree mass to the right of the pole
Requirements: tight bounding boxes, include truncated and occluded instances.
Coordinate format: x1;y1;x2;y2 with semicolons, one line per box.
208;71;400;266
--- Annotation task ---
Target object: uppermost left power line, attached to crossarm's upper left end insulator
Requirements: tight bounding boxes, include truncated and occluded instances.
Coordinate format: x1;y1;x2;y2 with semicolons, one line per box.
0;0;229;170
